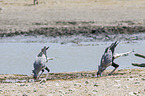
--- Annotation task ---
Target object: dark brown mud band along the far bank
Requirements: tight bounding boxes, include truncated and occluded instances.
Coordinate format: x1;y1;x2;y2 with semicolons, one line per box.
0;26;145;37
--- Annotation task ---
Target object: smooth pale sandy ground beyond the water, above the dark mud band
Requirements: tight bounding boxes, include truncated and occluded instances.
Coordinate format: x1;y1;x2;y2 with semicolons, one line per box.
0;0;145;33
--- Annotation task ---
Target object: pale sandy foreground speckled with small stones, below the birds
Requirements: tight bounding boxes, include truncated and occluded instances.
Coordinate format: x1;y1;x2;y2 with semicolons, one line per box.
0;69;145;96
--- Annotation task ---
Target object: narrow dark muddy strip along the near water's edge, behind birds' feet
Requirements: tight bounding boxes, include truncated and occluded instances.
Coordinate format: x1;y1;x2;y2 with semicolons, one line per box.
0;68;144;83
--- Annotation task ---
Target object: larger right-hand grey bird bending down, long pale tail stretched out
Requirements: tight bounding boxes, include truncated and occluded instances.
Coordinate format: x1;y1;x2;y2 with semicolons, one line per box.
97;41;134;77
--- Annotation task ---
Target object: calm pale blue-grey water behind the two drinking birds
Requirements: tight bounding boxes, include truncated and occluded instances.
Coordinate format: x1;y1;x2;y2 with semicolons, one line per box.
0;40;145;75
